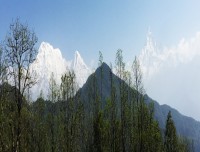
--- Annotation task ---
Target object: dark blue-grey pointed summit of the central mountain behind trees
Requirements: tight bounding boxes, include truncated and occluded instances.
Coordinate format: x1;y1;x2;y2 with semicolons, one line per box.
79;62;128;107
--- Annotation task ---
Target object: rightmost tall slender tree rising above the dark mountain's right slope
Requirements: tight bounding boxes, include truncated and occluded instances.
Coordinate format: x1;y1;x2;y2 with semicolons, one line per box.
131;57;146;152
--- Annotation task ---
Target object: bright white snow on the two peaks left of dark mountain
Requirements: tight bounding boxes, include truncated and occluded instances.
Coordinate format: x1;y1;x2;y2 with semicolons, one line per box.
31;42;91;100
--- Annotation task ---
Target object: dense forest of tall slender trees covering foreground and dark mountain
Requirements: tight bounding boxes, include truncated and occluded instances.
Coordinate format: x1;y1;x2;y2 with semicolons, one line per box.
0;19;194;152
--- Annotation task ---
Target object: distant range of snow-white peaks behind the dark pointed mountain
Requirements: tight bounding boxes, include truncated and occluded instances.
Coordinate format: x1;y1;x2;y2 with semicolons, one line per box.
30;31;155;101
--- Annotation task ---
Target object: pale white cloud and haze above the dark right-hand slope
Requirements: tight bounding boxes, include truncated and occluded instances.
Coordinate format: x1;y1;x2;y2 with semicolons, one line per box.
139;32;200;120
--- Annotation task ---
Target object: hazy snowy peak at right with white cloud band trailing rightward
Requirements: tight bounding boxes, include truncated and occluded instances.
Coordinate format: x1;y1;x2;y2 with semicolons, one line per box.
139;30;200;81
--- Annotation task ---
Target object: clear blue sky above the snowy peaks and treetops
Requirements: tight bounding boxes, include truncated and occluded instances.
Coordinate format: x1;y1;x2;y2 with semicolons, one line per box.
0;0;200;64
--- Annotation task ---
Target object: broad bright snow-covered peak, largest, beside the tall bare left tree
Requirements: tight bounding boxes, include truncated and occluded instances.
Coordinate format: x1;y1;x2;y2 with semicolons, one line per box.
31;42;68;100
